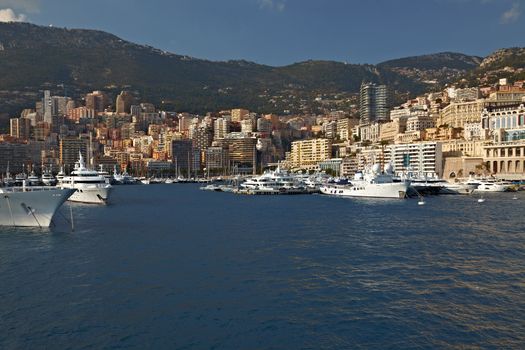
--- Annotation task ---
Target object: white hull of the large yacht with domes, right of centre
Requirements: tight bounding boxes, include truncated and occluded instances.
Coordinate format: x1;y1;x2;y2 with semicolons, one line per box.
320;182;408;199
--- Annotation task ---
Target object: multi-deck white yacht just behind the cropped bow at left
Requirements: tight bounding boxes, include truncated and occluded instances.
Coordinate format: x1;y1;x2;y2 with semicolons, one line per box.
57;153;112;204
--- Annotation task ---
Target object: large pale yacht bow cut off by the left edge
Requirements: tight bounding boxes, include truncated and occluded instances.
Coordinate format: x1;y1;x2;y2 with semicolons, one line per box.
0;186;75;227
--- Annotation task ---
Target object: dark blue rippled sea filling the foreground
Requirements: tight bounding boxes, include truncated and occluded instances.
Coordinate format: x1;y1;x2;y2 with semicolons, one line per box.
0;184;525;349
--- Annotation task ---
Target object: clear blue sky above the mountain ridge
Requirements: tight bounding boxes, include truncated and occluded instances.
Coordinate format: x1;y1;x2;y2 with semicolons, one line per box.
0;0;525;66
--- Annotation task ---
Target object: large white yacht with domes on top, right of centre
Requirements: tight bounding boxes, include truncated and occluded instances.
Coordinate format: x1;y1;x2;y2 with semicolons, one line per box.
320;164;408;198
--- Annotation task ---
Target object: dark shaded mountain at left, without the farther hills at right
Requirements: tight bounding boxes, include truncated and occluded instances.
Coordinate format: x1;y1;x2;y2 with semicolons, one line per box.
0;23;402;113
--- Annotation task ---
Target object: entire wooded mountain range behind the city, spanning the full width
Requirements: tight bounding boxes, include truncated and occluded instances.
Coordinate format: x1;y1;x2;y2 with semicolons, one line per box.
0;23;524;123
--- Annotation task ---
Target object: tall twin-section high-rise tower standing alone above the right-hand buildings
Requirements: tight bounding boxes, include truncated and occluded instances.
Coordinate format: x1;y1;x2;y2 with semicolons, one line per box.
359;82;390;124
